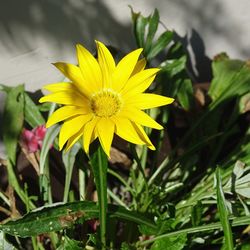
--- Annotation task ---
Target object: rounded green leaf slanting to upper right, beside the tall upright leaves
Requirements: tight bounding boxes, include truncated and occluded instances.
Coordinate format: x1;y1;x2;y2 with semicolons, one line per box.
147;31;173;60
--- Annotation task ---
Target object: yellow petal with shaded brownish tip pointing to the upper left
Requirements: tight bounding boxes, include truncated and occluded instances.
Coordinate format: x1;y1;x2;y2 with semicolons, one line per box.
54;62;94;96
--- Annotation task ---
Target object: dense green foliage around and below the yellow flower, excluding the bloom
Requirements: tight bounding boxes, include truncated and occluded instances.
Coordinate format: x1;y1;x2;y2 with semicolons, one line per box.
0;7;250;250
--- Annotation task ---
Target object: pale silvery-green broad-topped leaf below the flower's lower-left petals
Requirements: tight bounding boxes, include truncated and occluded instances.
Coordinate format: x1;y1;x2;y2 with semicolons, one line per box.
62;143;82;202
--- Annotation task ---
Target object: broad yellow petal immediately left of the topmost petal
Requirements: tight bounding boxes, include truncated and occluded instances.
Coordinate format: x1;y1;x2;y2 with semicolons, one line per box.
76;44;102;92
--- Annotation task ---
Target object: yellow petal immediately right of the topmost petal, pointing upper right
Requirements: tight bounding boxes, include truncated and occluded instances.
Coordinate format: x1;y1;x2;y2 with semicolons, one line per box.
112;49;142;92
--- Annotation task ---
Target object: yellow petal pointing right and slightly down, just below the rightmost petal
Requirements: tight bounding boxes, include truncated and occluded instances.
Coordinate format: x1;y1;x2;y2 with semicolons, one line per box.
119;108;163;129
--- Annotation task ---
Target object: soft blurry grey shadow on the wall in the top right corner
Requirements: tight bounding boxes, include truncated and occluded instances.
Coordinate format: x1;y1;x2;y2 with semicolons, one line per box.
161;0;250;58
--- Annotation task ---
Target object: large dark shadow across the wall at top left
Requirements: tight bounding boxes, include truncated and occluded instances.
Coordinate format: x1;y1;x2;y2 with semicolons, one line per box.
0;0;135;51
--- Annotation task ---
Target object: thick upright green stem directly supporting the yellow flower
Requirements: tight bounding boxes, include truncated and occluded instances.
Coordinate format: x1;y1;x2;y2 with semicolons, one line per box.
90;146;108;250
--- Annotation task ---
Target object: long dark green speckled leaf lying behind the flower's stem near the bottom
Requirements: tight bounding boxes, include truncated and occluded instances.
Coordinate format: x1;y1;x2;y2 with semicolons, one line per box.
0;201;156;237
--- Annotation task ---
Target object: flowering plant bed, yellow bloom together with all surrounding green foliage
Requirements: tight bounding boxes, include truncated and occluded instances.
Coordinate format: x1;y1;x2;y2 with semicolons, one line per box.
0;7;250;250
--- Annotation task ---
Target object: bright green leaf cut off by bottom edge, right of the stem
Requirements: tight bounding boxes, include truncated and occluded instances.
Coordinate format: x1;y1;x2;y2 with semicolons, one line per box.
150;233;187;250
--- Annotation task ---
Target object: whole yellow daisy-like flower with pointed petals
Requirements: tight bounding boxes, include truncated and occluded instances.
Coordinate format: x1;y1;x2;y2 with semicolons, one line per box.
40;41;174;156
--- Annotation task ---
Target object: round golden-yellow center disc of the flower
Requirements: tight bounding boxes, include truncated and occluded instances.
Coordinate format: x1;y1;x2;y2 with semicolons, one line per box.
90;89;122;117
